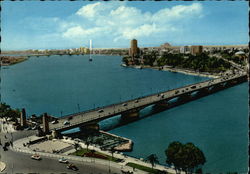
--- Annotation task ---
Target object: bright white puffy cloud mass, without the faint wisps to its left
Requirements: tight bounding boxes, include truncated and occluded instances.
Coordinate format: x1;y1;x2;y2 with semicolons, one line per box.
62;2;202;46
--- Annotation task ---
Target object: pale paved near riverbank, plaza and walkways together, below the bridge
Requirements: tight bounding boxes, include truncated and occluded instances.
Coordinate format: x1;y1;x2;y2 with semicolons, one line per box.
11;136;180;174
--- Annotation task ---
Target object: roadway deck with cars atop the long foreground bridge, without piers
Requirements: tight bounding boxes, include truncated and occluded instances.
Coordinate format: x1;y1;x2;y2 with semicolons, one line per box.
49;74;246;130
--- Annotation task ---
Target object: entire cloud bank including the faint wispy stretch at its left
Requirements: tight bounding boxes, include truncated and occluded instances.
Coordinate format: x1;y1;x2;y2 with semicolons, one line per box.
15;2;203;47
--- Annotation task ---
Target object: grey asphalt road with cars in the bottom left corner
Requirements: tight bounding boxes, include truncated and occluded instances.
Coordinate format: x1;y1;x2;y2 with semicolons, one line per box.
0;131;121;174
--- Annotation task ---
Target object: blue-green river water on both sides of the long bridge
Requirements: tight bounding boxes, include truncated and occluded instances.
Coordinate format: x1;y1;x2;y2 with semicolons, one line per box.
1;56;248;173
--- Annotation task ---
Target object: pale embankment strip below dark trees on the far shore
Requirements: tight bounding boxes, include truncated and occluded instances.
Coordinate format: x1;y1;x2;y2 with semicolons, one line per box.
127;65;220;78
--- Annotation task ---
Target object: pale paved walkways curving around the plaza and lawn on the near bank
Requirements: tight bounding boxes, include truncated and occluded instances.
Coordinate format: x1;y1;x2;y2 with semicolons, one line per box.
12;137;184;174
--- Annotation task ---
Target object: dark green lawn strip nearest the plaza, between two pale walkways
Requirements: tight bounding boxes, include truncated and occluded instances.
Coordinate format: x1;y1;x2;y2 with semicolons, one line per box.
71;149;121;162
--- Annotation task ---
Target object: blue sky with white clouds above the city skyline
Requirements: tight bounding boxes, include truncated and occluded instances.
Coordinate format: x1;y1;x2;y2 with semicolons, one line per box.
1;1;249;50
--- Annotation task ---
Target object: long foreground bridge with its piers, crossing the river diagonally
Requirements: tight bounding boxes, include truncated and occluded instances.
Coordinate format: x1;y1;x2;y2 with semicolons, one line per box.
43;73;247;133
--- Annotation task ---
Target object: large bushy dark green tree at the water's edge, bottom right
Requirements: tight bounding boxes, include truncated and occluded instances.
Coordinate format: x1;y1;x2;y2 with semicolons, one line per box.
165;142;206;173
